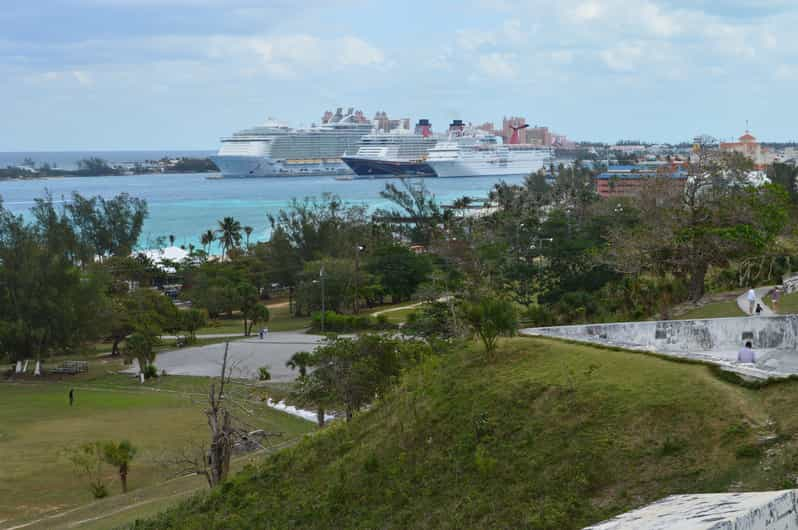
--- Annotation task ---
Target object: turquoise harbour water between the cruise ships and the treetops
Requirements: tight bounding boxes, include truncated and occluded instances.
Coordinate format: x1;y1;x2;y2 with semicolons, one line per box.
0;174;523;248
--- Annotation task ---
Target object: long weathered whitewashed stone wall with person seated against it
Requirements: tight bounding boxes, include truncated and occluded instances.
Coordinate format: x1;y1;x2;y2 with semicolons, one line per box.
521;315;798;379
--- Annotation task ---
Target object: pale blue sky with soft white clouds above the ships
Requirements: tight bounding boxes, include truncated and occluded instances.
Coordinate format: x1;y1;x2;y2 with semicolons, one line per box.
0;0;798;151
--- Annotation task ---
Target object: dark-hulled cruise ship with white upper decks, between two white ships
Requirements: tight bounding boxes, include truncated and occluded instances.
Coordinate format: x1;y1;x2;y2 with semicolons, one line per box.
341;119;438;179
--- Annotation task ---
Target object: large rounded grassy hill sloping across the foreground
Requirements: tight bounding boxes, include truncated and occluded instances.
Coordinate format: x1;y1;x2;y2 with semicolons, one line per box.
128;338;798;529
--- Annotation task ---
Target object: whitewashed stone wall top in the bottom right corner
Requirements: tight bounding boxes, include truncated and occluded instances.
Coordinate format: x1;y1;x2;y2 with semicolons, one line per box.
584;490;798;530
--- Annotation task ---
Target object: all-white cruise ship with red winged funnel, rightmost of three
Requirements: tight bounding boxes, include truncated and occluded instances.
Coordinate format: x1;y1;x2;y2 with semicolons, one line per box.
426;120;553;178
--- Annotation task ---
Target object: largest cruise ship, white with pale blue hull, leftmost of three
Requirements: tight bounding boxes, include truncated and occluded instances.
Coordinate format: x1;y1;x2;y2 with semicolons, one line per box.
211;108;373;178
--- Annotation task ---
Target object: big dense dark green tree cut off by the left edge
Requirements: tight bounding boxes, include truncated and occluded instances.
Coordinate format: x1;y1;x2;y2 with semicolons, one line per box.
0;200;110;360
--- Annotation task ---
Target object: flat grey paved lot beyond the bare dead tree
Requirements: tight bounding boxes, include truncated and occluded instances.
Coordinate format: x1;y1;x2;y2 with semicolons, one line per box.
126;331;322;381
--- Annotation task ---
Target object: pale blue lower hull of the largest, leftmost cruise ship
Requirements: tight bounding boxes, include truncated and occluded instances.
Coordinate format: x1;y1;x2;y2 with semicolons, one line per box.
210;155;352;178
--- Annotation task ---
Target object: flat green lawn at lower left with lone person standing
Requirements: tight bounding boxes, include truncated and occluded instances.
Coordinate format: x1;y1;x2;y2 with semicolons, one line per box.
0;352;314;528
